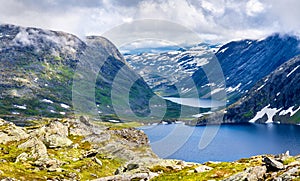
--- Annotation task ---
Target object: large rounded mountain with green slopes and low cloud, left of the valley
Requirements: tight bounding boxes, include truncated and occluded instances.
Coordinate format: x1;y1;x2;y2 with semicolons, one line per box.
0;25;154;119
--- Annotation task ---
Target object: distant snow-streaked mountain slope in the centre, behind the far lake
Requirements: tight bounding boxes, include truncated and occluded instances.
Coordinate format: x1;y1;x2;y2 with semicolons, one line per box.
124;44;218;96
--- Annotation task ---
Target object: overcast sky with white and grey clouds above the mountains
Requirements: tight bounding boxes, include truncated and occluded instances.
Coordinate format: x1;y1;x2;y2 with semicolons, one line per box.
0;0;300;46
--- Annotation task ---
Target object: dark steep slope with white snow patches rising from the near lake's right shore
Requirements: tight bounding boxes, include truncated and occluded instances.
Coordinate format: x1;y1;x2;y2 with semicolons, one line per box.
225;56;300;124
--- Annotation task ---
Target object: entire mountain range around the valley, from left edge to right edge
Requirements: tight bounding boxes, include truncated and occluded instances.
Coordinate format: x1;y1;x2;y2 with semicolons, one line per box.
0;25;300;124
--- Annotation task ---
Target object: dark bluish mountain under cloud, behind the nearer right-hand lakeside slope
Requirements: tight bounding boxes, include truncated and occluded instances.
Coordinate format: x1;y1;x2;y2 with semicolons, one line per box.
193;34;300;104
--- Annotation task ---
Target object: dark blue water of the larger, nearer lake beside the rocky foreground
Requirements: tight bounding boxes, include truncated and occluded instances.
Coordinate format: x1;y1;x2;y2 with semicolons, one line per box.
141;124;300;163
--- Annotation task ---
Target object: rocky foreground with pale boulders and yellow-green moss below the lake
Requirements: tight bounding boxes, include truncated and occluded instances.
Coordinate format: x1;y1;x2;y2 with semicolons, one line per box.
0;117;300;181
